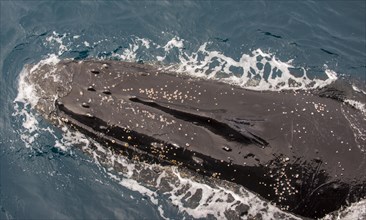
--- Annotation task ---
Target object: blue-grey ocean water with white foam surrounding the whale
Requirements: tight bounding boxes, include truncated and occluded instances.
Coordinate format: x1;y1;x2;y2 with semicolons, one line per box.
0;0;366;219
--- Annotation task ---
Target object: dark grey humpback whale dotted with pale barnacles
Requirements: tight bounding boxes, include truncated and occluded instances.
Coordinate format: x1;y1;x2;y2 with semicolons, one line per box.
26;60;366;218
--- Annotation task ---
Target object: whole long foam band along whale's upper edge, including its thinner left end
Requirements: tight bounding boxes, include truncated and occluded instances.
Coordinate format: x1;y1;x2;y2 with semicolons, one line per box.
109;36;338;91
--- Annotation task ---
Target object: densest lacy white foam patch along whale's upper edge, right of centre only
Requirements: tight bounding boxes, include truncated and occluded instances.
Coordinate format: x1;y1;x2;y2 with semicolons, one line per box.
169;43;337;91
